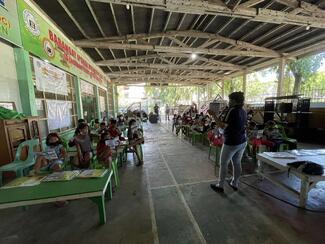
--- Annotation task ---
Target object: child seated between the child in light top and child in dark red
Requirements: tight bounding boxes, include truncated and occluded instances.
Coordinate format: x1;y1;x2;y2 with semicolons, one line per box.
73;123;93;169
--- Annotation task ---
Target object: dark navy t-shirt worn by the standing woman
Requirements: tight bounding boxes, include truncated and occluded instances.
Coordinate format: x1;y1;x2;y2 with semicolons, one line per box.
223;106;247;146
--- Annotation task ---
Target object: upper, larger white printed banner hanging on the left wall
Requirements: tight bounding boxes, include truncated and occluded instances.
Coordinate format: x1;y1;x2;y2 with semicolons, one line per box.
33;58;68;95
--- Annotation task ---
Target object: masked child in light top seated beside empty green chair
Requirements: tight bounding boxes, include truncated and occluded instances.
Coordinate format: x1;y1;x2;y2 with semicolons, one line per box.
34;133;66;174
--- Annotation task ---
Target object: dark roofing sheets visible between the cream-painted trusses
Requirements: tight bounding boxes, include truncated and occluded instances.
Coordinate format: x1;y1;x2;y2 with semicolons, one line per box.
35;0;325;84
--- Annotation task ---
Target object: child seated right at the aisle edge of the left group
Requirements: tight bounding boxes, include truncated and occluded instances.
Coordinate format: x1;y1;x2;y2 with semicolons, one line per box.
128;119;143;166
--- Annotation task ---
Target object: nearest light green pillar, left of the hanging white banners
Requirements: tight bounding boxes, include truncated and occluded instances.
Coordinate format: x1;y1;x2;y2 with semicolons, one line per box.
14;48;37;116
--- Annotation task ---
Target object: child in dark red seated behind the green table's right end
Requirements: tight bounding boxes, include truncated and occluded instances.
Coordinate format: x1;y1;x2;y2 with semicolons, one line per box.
96;132;112;168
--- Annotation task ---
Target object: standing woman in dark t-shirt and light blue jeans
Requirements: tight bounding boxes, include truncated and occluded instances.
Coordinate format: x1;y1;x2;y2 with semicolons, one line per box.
209;92;247;193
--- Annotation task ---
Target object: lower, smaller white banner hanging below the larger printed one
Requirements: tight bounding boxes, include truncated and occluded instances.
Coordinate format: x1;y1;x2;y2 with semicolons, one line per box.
46;100;71;130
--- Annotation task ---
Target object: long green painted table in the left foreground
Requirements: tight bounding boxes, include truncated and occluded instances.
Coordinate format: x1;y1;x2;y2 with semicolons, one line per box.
0;171;113;224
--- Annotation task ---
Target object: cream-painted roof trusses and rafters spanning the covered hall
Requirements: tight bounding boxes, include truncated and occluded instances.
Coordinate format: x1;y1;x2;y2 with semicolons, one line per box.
31;0;325;84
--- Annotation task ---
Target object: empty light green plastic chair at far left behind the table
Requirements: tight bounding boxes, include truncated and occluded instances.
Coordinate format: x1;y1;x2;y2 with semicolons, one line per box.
0;139;39;186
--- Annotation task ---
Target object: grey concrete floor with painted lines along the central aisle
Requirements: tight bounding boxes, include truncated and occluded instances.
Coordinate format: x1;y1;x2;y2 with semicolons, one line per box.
0;125;325;244
